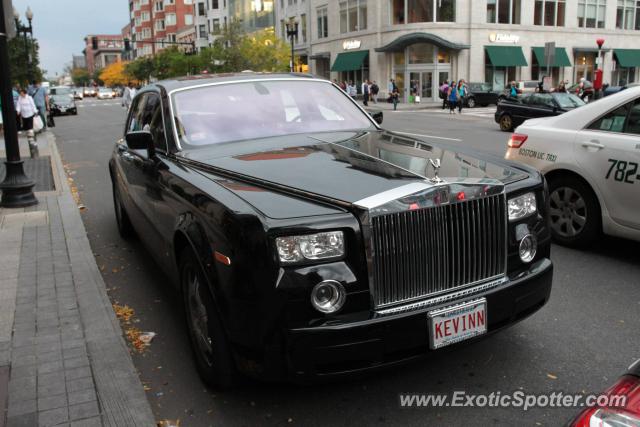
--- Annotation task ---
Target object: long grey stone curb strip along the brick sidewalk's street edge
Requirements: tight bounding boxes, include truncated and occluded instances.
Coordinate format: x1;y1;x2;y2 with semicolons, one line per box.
47;133;156;426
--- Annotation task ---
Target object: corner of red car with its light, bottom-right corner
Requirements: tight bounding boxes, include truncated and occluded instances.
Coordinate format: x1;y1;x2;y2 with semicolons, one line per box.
569;360;640;427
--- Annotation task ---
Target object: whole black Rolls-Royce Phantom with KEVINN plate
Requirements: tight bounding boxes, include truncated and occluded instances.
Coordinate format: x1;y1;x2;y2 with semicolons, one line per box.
109;73;553;387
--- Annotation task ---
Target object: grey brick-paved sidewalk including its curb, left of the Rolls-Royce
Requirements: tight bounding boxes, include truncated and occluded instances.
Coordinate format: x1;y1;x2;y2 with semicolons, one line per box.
0;132;155;427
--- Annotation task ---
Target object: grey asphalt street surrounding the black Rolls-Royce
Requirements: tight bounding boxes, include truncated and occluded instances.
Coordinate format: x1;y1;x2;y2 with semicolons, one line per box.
53;99;640;427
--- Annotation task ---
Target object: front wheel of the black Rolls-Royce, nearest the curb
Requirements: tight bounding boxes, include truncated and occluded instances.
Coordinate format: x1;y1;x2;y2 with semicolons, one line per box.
180;248;237;389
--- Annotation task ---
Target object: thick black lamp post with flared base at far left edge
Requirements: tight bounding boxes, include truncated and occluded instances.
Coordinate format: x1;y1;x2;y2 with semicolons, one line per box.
0;1;38;208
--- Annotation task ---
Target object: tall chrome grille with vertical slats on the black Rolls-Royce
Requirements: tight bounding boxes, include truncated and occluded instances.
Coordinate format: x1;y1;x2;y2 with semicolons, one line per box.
371;194;507;308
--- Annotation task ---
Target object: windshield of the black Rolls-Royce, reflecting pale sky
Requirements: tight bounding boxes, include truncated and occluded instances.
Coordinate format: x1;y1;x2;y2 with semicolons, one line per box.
173;80;375;146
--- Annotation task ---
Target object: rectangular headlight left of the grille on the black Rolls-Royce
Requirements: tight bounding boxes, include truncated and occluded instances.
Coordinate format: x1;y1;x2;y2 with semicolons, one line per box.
276;231;344;264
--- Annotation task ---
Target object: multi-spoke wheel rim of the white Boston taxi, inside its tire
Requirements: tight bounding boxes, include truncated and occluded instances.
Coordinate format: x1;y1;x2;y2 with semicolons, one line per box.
549;187;587;237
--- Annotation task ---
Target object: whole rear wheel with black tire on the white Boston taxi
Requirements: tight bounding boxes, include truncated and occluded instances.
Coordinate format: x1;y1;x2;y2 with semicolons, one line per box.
549;175;602;248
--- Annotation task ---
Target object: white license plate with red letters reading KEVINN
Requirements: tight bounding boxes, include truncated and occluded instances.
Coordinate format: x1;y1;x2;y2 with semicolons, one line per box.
427;298;487;350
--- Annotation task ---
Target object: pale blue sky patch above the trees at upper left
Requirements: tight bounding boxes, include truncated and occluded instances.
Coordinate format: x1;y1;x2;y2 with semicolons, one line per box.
13;0;129;77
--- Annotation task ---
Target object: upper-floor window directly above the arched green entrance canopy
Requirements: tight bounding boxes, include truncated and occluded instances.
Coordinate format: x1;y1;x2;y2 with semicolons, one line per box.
390;0;456;24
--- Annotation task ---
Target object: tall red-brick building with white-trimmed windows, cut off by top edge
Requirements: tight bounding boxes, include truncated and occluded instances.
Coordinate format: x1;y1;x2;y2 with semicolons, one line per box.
129;0;194;58
